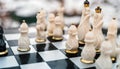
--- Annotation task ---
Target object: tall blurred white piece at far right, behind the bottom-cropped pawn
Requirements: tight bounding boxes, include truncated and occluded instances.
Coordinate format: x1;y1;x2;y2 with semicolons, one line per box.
107;18;117;58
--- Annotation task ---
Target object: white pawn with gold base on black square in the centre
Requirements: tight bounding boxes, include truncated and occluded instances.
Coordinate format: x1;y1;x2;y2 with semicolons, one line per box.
65;25;78;54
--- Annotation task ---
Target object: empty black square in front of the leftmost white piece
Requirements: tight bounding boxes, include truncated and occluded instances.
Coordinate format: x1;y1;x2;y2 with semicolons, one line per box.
15;53;43;64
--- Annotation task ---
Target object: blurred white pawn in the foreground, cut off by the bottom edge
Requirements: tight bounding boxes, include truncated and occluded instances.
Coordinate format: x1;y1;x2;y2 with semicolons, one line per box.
95;40;112;69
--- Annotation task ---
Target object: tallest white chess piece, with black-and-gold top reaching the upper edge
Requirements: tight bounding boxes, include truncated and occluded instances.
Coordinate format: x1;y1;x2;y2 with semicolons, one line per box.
78;0;91;44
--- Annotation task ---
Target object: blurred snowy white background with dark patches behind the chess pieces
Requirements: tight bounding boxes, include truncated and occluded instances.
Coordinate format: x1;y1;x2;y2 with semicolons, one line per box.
0;0;120;28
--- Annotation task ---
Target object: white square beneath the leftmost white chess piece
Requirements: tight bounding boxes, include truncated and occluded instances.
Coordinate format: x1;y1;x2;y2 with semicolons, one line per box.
11;45;36;55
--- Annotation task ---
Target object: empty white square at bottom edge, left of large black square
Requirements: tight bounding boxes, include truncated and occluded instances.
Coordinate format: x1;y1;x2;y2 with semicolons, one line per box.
20;62;51;69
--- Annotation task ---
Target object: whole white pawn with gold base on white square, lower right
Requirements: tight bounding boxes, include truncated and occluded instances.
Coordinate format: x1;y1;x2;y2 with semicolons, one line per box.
81;31;96;64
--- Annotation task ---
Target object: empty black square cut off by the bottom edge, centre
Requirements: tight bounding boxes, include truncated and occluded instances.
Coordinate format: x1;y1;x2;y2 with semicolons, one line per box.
47;59;79;69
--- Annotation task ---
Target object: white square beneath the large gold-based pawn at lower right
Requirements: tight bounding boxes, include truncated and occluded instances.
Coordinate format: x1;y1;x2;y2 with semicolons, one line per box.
70;57;95;69
